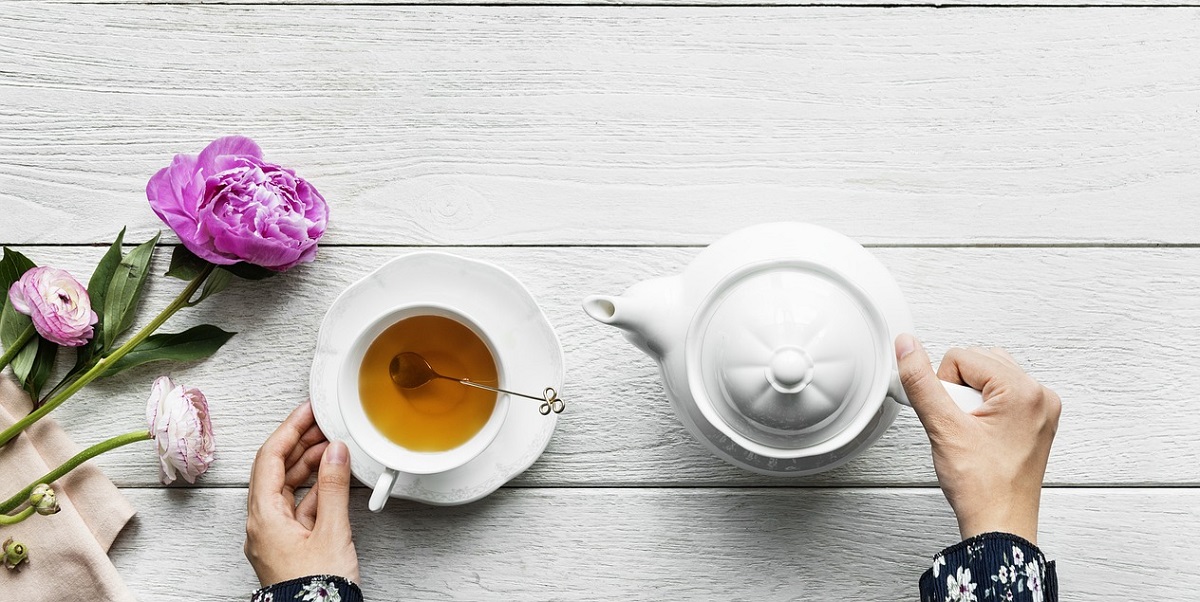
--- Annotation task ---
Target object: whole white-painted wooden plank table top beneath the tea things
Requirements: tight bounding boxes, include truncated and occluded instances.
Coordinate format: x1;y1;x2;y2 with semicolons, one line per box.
0;0;1200;601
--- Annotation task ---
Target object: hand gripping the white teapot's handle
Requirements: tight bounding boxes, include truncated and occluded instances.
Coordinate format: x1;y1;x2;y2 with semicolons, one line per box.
895;333;1062;544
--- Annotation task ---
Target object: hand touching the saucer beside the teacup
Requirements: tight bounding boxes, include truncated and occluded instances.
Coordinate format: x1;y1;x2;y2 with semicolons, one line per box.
244;402;359;586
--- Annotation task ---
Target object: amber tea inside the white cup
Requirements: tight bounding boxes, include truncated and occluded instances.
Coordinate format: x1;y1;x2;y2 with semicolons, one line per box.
359;315;498;452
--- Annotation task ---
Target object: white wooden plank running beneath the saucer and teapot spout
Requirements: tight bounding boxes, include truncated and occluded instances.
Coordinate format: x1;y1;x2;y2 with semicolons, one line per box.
4;248;1200;487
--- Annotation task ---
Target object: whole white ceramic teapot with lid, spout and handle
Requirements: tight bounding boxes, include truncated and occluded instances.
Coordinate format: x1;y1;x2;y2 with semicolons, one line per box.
583;223;983;476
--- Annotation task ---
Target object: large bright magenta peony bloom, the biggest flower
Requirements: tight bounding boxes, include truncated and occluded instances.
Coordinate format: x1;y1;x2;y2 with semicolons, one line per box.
146;136;329;271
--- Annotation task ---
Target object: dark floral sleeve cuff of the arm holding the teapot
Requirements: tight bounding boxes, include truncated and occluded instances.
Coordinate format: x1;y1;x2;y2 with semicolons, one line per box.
920;532;1058;602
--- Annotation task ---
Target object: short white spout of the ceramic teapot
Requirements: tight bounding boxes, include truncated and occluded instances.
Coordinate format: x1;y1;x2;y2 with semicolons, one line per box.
583;278;679;359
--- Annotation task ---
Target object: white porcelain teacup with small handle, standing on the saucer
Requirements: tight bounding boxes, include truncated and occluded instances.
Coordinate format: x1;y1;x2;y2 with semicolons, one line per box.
337;303;511;512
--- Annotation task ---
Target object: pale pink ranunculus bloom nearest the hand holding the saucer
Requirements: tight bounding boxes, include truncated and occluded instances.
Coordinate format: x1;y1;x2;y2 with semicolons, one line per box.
146;377;216;484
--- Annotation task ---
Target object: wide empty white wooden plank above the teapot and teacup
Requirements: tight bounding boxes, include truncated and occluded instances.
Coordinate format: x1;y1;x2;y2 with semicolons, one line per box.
0;4;1200;245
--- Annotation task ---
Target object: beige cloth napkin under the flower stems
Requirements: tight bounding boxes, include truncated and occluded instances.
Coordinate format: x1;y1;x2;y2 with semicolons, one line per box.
0;378;137;602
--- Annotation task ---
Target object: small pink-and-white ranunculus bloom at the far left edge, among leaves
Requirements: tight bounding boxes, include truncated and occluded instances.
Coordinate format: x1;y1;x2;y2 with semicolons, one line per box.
8;267;100;347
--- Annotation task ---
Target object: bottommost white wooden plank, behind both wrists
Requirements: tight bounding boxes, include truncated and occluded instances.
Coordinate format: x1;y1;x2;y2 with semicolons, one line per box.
112;489;1200;602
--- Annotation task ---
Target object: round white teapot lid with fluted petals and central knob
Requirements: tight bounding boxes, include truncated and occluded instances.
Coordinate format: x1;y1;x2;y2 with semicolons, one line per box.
686;259;890;449
